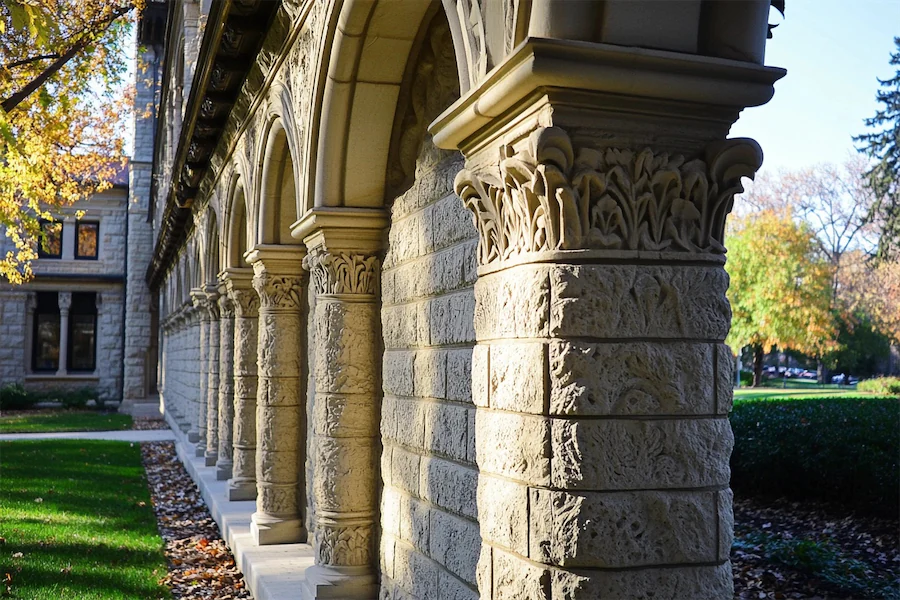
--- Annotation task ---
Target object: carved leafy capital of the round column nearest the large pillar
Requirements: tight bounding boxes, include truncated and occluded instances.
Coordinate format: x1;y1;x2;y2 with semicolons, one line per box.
303;247;379;296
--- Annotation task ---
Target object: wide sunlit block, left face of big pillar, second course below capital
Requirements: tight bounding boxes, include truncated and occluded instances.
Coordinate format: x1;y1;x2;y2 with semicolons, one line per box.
490;342;546;414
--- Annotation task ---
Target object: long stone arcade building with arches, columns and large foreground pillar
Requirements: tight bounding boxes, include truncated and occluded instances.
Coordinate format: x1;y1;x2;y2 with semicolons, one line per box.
146;0;784;600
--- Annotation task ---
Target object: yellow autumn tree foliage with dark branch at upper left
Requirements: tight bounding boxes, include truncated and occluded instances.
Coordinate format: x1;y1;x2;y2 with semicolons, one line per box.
0;0;138;283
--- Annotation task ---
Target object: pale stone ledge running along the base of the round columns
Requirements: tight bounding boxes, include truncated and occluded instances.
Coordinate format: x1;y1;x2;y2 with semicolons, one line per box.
166;412;314;600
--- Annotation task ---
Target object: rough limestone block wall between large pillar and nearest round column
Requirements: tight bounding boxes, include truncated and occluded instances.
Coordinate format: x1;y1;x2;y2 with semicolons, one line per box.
380;151;481;599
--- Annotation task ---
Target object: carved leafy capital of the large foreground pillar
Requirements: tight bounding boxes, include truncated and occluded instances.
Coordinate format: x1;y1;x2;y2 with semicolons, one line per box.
455;127;762;265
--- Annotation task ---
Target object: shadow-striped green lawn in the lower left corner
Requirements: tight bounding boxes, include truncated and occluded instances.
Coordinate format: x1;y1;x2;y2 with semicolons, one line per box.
0;440;171;600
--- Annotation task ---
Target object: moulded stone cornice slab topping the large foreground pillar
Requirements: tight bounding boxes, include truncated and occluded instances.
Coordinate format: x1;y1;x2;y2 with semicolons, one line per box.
429;38;786;155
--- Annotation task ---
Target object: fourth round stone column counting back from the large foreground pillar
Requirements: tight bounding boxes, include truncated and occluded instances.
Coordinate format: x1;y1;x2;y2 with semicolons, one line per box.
216;281;234;481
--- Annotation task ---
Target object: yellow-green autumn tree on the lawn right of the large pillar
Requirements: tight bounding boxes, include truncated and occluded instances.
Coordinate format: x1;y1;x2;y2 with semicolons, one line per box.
726;210;836;386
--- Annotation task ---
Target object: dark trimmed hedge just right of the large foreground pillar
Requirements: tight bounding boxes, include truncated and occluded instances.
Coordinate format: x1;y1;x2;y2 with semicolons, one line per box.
731;397;900;517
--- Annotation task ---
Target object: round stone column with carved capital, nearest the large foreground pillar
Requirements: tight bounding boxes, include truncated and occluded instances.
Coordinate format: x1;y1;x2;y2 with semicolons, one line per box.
292;209;387;599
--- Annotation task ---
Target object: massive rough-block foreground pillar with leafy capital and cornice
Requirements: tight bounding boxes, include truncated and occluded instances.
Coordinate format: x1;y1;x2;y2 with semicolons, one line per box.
432;39;781;600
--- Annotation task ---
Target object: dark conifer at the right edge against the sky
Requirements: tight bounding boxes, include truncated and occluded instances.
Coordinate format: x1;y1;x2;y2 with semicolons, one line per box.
853;37;900;258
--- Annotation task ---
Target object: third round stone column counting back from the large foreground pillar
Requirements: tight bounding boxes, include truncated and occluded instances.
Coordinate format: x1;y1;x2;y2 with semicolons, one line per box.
226;269;259;500
